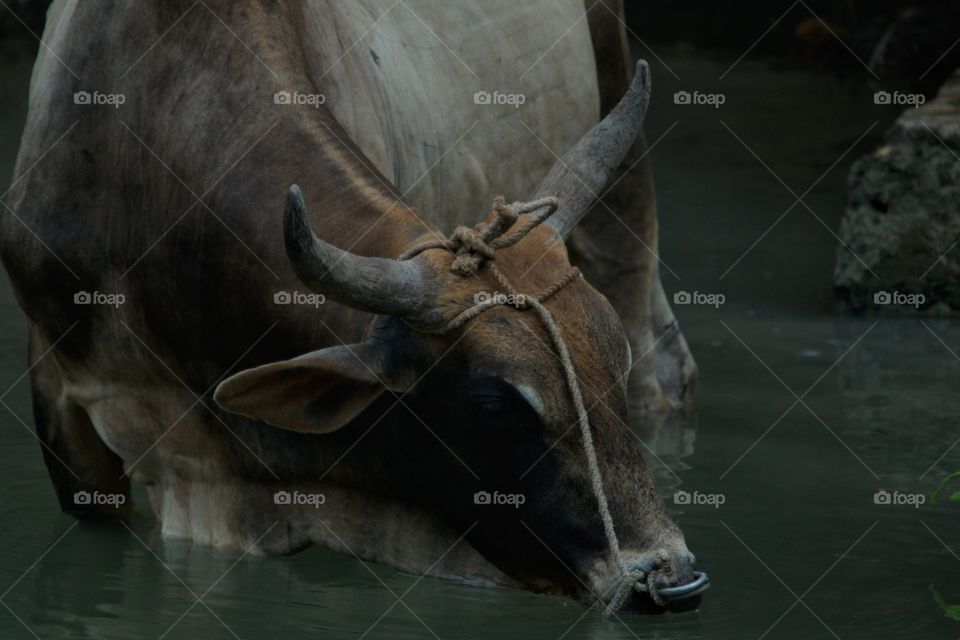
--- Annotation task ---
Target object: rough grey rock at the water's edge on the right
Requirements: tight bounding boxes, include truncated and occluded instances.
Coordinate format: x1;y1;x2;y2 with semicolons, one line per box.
833;70;960;315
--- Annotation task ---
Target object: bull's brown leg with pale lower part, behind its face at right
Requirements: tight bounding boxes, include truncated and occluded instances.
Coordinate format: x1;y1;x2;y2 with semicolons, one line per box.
567;135;697;414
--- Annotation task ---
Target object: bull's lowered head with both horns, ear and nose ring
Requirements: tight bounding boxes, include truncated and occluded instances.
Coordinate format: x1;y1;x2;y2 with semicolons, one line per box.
216;63;704;610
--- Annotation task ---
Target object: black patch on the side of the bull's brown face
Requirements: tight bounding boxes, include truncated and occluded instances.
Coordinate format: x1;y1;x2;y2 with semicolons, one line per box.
378;362;603;593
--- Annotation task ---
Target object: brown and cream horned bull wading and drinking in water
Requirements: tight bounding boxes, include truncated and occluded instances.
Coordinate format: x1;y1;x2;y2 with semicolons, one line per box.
2;0;703;610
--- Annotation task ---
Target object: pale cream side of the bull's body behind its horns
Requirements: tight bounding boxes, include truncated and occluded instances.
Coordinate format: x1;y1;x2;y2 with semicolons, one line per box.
304;0;599;229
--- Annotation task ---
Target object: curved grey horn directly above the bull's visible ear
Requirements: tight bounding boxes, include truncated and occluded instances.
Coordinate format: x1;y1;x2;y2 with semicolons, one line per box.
283;185;430;318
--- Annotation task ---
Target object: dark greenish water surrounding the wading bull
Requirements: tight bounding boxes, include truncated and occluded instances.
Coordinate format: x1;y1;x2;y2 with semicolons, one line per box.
0;37;960;640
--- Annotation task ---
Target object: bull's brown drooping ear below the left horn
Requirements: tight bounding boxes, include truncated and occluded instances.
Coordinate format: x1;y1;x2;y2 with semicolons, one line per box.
213;342;398;433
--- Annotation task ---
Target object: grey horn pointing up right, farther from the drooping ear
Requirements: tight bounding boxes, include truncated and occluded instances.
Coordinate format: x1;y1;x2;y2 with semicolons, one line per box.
534;60;650;239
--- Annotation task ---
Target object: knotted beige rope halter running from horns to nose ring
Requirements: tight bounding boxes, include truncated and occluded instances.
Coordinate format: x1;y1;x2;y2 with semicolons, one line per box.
399;196;669;617
